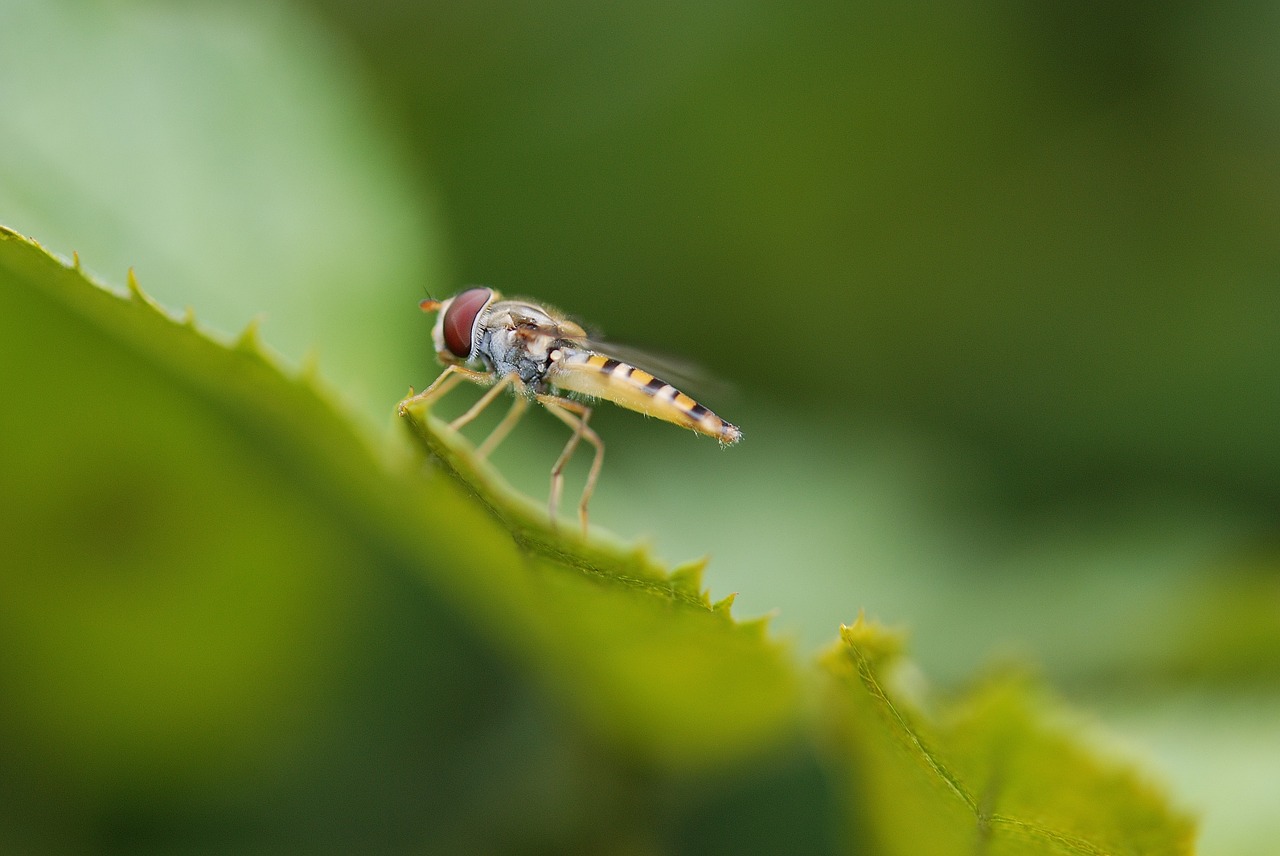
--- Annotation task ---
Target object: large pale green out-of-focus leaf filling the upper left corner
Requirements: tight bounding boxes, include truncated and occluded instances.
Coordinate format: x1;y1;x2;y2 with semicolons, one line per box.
0;0;442;422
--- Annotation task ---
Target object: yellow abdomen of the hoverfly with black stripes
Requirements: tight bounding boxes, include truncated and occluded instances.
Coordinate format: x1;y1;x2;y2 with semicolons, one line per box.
547;351;742;444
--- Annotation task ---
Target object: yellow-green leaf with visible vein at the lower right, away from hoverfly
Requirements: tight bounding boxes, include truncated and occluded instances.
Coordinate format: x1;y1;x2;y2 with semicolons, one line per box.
828;619;1194;856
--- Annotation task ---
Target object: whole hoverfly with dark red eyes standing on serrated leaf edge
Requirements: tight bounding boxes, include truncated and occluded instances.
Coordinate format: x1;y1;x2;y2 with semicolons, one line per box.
399;288;742;534
